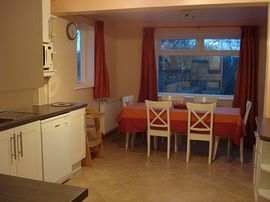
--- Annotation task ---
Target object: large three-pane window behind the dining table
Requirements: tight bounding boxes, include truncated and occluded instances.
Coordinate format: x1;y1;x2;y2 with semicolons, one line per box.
156;29;240;96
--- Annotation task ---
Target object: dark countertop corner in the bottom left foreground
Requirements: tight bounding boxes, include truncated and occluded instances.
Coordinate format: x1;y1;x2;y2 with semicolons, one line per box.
0;174;88;202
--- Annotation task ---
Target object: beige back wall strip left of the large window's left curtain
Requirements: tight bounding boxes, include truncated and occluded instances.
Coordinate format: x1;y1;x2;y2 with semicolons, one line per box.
116;23;144;100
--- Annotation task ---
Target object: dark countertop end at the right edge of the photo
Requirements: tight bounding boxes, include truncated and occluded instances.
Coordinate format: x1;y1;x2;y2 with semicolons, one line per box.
256;117;270;142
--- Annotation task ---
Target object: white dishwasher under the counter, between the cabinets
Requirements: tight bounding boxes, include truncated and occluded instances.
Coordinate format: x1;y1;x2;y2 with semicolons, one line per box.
41;114;72;182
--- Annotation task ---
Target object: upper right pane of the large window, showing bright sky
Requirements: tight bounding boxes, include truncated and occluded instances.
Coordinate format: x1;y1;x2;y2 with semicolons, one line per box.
204;39;240;51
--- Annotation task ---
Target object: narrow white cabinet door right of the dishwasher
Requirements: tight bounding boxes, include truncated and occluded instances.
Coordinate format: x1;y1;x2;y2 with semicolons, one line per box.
70;108;85;164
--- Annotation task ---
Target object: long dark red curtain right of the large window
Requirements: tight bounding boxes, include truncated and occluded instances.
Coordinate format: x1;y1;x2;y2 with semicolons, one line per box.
233;26;258;147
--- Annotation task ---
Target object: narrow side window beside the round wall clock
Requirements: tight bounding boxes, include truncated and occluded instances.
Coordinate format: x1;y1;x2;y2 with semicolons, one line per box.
77;25;95;89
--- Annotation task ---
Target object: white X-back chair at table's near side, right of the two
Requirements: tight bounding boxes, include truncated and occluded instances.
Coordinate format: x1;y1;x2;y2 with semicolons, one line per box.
186;103;216;164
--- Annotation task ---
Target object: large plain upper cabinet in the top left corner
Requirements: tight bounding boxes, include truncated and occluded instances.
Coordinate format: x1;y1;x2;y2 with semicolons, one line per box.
0;0;44;92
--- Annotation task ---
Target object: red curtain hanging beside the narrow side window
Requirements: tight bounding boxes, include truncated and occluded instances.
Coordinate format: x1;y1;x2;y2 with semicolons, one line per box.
94;21;110;98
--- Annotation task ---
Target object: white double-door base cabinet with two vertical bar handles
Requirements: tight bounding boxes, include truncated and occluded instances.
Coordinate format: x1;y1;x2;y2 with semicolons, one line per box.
0;121;42;180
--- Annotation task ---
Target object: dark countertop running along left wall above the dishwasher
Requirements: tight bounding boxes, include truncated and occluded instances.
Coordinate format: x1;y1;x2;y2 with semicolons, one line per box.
0;103;87;131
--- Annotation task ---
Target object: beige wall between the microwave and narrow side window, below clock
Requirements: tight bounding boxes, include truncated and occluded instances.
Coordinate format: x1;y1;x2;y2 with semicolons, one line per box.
48;18;96;108
